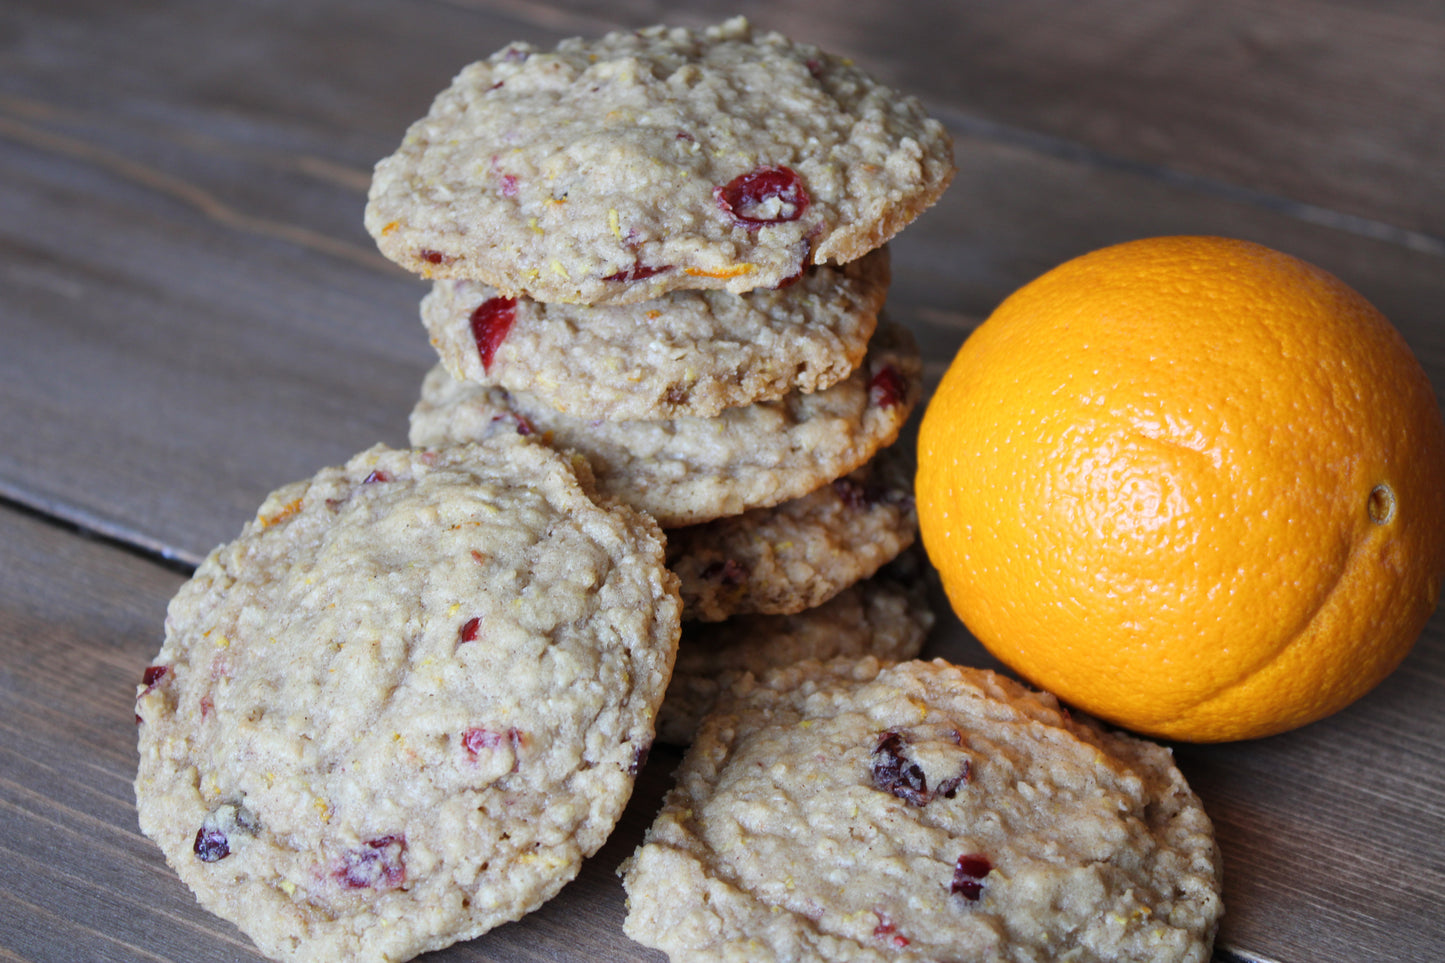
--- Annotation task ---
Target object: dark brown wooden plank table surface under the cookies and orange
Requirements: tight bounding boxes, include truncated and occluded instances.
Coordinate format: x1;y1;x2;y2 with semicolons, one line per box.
0;0;1445;963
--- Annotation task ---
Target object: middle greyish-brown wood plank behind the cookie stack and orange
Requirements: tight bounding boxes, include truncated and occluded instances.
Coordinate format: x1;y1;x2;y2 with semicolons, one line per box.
0;0;1445;560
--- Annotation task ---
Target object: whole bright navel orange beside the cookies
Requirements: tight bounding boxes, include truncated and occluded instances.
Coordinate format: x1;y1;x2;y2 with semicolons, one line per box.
918;237;1445;742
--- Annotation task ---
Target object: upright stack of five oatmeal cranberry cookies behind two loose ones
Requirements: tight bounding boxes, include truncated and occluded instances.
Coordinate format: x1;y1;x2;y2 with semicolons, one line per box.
366;19;954;742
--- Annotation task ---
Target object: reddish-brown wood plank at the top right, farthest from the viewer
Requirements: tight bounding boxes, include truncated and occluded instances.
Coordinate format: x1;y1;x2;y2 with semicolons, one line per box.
485;0;1445;250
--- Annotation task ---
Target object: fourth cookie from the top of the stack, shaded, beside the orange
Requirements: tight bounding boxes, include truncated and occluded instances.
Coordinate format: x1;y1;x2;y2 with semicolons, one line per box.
668;448;918;622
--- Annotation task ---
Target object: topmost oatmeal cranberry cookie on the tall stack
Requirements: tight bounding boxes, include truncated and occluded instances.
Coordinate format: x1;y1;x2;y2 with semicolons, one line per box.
366;17;954;304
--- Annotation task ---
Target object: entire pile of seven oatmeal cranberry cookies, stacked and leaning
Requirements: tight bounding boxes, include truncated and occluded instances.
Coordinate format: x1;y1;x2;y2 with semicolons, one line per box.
136;20;1221;963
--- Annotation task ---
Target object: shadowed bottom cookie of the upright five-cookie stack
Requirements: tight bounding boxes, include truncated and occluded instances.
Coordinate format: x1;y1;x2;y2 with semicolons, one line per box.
657;549;933;745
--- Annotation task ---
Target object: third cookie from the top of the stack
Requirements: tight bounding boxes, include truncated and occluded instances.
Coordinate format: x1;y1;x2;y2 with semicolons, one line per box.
410;322;922;528
